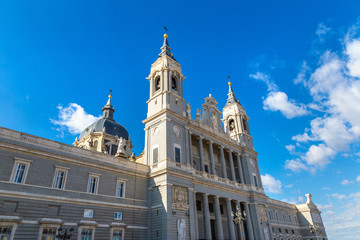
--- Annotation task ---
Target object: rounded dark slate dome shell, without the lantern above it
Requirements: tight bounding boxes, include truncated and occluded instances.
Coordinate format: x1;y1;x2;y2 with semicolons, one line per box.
80;118;129;140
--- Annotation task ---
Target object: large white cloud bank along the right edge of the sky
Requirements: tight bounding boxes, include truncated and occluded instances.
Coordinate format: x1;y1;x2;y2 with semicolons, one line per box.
285;23;360;171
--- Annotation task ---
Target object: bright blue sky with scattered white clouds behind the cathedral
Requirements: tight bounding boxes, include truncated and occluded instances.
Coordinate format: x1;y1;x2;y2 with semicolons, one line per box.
0;0;360;239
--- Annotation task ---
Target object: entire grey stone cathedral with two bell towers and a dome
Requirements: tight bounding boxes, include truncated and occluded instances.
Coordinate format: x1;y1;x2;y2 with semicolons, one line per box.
0;34;327;240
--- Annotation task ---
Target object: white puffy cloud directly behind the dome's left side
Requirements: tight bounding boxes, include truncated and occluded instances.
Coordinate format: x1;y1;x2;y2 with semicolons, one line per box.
50;103;100;136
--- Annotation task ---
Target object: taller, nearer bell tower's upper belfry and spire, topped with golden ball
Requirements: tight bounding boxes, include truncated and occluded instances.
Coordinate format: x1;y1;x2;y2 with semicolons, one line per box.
147;33;185;117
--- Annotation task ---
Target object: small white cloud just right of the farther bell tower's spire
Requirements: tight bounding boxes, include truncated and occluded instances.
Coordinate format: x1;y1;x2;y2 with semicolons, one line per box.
263;91;309;119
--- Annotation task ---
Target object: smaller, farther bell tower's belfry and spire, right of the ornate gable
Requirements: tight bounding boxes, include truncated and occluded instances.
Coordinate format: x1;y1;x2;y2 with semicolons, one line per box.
222;82;253;148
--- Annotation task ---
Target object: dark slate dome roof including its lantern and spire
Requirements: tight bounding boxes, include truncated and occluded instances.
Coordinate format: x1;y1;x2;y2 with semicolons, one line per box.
80;91;129;140
